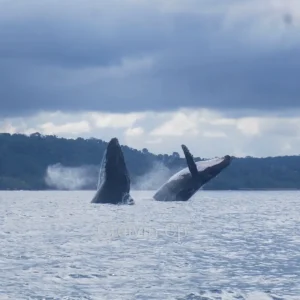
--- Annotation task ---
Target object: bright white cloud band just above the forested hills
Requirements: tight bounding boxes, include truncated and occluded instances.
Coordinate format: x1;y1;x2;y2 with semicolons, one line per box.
0;109;300;158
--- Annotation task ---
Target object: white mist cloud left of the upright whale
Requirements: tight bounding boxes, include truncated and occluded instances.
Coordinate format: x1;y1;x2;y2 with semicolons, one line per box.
45;164;96;190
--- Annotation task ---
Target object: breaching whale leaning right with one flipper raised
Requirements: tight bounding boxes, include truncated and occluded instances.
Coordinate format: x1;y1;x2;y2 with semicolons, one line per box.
153;145;232;201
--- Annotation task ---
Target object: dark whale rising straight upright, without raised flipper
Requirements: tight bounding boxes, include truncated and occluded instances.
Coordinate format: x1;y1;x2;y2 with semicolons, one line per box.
92;138;134;204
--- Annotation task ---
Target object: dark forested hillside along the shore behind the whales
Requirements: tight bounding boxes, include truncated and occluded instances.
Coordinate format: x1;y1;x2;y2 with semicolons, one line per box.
0;133;300;190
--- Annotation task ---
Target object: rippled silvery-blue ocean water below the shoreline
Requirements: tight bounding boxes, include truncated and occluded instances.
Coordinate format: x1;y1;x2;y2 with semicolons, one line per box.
0;191;300;300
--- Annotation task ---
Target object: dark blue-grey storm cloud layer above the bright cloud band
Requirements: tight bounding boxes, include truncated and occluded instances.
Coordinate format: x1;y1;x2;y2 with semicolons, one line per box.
0;0;300;116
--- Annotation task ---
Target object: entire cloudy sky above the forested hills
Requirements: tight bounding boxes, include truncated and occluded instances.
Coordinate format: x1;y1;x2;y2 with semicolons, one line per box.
0;0;300;158
